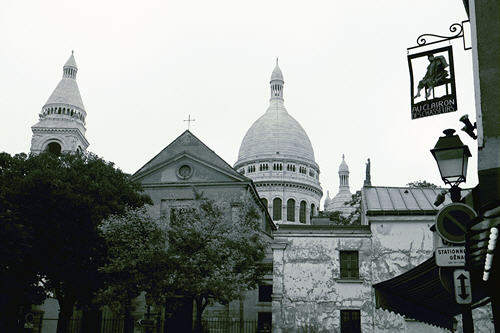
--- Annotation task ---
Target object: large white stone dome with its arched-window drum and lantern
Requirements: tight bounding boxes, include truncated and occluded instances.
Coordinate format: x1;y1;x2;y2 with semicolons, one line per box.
234;63;323;224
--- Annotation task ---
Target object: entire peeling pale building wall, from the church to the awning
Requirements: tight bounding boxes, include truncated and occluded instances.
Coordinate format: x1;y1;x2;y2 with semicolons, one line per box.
273;215;456;333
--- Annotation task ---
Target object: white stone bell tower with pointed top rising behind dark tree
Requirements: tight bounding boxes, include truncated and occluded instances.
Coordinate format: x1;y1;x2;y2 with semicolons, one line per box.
30;52;89;154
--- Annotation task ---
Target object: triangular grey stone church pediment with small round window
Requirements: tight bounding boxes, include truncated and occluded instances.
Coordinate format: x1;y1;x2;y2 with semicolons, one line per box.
132;131;250;184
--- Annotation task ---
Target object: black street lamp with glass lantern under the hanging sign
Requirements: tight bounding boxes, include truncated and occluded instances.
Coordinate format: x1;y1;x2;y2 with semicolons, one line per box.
431;129;472;202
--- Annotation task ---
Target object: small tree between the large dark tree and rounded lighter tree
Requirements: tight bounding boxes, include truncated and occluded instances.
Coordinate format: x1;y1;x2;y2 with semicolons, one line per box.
99;207;168;333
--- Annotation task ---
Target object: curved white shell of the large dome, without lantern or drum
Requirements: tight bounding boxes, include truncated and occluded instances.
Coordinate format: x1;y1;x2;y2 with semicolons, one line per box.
237;100;315;164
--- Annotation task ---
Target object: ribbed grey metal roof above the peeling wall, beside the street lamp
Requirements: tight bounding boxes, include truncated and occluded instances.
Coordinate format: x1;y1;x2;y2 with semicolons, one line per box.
361;186;470;215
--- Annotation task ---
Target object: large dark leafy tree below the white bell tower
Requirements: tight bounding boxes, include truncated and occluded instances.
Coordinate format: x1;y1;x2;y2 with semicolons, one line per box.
0;153;151;333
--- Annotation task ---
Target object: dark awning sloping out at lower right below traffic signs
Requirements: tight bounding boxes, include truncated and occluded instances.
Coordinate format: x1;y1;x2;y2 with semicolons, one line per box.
373;257;485;330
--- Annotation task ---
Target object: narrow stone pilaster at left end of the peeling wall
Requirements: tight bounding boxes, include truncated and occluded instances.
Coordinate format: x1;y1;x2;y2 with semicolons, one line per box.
271;240;287;333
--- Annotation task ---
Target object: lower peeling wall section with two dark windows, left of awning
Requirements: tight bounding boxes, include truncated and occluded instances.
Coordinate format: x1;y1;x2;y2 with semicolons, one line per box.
273;226;374;332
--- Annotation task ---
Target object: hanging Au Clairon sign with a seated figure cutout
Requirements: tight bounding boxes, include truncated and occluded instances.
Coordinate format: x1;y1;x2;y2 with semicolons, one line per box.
408;45;457;119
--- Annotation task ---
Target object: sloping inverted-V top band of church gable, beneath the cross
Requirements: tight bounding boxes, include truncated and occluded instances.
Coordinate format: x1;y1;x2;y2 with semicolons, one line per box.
132;130;251;182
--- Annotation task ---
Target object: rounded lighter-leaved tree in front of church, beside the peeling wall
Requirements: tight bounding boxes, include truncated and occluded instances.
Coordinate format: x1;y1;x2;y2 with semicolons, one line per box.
167;192;267;332
